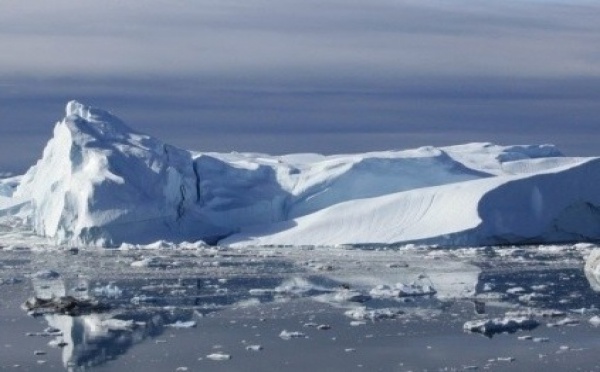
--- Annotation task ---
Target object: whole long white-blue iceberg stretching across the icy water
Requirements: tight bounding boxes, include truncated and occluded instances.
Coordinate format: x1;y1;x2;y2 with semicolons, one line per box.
0;101;600;247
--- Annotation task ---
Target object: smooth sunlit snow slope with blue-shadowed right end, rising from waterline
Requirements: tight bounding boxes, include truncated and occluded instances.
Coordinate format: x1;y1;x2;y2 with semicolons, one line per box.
223;159;600;245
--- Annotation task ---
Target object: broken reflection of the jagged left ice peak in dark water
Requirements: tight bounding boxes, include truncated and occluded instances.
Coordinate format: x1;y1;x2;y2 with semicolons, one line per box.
32;279;193;371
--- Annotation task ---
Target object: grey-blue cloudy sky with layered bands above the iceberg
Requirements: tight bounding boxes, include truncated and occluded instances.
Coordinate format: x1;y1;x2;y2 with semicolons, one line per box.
0;0;600;171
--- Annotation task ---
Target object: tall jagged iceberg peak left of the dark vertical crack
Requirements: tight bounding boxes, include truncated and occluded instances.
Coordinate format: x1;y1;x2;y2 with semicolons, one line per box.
15;101;202;244
